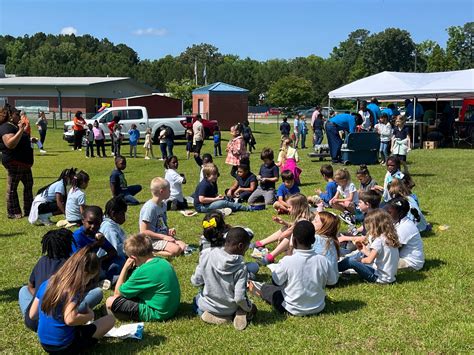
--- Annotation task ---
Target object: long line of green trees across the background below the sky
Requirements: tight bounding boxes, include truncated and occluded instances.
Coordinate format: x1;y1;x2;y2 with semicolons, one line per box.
0;22;474;111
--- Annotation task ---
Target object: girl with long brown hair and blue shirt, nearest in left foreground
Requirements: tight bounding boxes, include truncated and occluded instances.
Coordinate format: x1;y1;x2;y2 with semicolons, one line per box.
30;247;115;354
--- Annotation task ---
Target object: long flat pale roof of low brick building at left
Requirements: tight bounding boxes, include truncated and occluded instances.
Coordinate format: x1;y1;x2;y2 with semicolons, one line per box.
0;76;131;86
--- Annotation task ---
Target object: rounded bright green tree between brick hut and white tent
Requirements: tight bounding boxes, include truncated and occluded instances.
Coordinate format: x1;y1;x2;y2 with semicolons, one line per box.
268;75;313;107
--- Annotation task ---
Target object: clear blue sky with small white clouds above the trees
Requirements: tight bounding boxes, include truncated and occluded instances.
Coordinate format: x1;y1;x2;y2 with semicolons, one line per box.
0;0;474;60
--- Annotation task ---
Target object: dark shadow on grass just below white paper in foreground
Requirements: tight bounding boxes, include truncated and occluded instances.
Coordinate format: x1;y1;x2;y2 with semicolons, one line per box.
94;334;166;354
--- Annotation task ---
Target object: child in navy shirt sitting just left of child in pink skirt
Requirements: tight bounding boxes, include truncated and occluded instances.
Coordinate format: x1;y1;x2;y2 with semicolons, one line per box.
249;148;280;206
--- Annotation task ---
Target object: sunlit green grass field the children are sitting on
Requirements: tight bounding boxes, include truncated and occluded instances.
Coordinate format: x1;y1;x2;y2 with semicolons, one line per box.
0;124;474;353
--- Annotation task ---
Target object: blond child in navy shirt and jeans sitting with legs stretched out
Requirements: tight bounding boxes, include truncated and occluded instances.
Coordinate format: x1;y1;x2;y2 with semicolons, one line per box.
194;163;250;213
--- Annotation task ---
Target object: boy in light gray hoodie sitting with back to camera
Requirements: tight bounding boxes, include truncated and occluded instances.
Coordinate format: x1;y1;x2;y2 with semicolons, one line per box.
191;227;256;330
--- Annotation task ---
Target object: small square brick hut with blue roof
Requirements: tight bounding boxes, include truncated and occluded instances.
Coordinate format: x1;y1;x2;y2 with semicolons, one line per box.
193;82;249;129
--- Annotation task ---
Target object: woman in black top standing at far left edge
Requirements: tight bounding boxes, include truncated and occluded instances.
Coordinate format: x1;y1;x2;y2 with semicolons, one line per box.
0;106;33;219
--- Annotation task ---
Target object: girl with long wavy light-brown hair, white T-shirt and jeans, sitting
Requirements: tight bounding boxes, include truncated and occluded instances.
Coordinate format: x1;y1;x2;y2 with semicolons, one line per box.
338;209;400;284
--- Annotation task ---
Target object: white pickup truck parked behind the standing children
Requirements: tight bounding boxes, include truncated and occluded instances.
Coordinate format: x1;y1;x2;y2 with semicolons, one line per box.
63;106;186;143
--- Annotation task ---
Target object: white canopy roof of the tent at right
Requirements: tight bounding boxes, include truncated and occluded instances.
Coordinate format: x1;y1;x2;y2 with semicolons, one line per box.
329;69;474;100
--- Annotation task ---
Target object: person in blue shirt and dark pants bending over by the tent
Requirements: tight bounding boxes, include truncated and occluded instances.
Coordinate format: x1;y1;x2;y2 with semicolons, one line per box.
326;113;362;163
